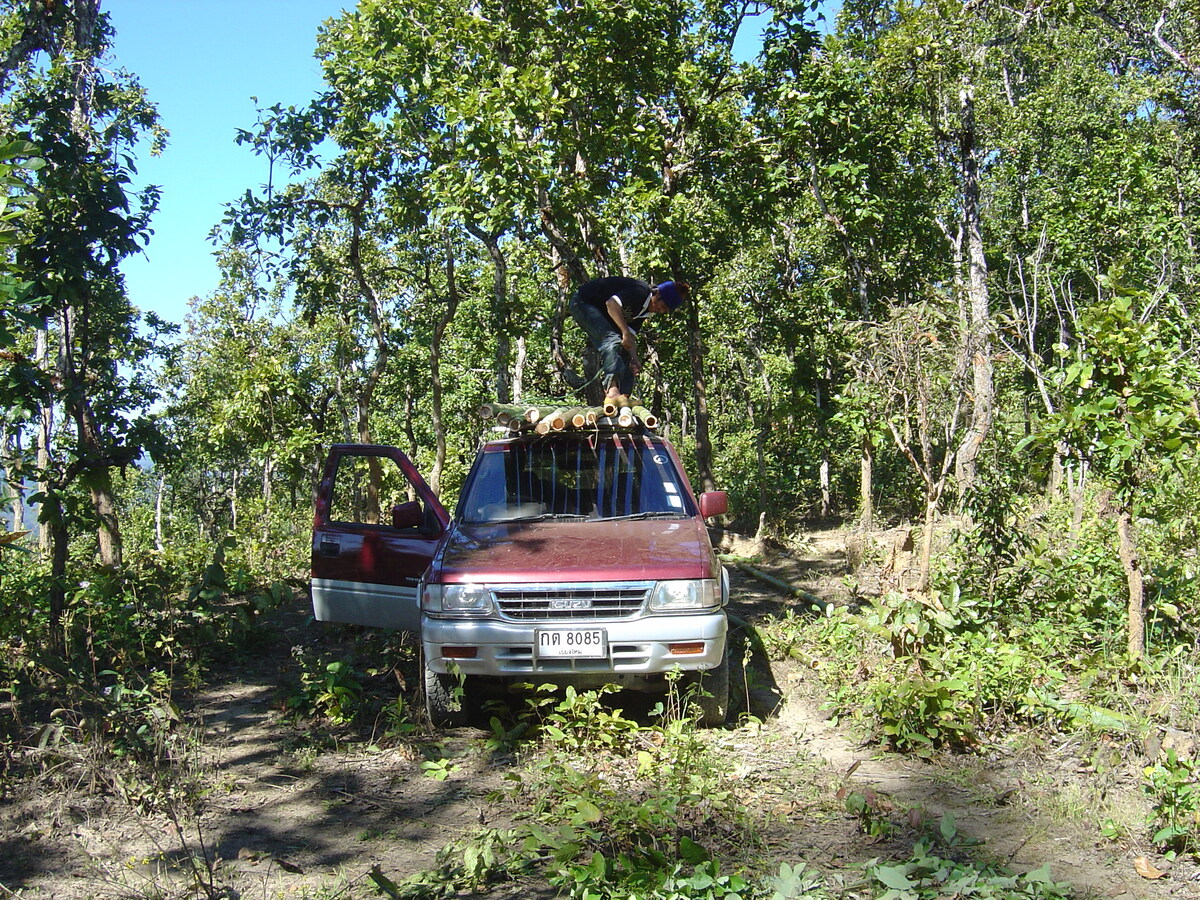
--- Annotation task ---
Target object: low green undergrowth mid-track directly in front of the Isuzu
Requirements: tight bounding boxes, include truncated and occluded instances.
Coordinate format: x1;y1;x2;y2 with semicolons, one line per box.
370;689;1066;900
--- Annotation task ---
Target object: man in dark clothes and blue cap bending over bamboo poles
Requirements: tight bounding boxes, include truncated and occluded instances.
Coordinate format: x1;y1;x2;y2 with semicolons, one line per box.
570;276;689;400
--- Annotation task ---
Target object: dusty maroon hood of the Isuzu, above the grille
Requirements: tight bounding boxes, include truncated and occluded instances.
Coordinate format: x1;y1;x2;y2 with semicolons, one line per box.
430;518;715;583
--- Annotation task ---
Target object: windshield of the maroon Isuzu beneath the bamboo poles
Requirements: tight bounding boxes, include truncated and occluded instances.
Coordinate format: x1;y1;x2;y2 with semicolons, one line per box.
458;434;696;524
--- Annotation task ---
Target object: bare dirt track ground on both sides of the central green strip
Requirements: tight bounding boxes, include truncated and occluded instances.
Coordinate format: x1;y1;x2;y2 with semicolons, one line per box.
0;530;1200;900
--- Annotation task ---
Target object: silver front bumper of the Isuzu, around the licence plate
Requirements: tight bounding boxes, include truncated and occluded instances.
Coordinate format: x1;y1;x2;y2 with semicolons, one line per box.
421;611;728;686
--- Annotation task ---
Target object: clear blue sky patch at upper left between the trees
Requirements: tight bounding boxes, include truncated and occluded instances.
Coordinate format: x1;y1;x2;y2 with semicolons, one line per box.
102;0;755;323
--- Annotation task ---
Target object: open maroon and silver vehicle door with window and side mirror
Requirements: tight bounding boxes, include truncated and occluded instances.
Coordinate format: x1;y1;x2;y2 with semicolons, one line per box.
312;444;450;631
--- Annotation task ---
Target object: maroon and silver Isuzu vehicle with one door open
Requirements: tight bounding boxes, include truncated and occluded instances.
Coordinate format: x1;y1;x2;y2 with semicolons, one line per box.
312;428;728;726
